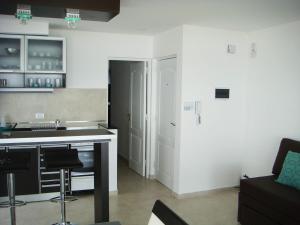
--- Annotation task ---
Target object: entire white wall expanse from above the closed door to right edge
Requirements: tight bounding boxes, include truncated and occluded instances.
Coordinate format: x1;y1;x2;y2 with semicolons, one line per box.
154;22;300;194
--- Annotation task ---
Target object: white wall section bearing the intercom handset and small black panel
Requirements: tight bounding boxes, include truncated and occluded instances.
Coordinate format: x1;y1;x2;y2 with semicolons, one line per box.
178;26;246;194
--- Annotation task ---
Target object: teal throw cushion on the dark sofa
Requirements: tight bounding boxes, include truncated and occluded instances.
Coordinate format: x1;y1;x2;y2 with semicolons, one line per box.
276;151;300;190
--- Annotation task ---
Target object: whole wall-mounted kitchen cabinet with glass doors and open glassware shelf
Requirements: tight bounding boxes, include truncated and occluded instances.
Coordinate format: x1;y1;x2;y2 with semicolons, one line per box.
0;34;67;93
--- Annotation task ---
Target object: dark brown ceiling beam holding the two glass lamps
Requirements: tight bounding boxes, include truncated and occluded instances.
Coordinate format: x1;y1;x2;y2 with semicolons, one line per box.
0;0;120;21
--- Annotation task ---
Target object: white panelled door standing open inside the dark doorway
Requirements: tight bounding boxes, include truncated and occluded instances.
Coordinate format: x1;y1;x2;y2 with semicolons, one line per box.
129;62;146;176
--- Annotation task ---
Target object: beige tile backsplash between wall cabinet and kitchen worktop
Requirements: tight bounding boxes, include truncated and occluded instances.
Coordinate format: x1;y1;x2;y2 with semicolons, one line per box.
0;89;108;122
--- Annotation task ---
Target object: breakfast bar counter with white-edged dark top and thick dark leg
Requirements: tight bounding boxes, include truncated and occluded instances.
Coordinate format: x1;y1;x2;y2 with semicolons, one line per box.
0;129;114;223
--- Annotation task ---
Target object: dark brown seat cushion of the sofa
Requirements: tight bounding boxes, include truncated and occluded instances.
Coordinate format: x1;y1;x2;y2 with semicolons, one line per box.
240;176;300;222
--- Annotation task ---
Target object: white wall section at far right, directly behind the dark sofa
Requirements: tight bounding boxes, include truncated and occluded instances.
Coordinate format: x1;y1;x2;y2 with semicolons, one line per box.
243;21;300;176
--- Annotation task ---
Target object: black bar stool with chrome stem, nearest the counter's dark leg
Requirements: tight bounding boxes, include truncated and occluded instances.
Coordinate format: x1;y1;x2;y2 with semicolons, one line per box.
44;148;83;225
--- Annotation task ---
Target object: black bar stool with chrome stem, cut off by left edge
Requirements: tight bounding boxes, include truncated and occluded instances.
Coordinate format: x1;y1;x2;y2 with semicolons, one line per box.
0;151;30;225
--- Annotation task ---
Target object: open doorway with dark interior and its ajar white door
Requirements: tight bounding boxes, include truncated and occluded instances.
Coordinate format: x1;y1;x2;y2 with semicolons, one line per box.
108;60;148;176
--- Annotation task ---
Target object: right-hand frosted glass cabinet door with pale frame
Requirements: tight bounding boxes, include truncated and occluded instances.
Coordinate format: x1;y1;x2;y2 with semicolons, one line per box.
25;37;66;73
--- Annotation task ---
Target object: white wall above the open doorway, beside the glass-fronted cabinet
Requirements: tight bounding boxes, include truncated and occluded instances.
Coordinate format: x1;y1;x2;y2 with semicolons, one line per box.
50;30;153;88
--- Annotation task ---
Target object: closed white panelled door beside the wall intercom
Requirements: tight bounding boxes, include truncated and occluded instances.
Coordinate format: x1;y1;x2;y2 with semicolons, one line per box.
156;58;177;189
